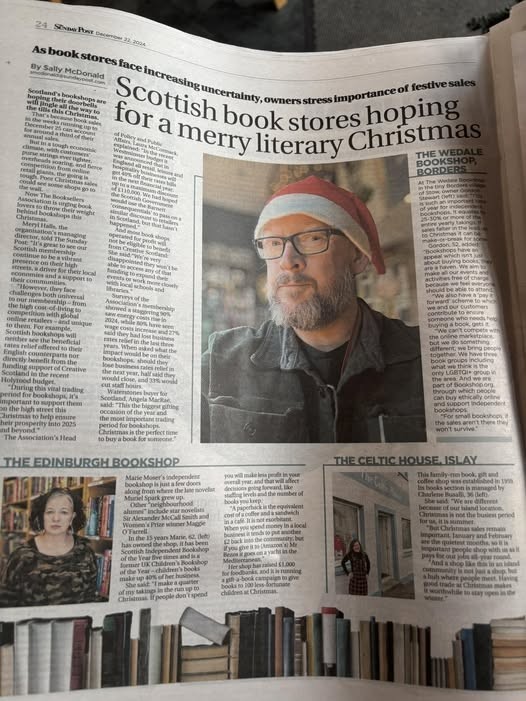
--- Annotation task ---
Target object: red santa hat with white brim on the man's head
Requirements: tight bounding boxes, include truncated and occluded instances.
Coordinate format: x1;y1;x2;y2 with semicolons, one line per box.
254;175;385;274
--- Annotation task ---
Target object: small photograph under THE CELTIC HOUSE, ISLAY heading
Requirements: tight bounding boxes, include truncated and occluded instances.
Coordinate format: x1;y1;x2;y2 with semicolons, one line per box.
332;472;415;599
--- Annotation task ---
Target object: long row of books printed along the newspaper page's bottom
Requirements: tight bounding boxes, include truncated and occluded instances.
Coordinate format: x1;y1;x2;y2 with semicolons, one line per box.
0;607;526;695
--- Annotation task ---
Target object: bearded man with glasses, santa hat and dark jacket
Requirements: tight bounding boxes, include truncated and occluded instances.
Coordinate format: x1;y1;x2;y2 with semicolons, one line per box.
201;176;426;443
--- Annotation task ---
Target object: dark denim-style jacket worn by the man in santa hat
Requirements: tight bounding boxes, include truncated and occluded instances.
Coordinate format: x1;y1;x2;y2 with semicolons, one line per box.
201;300;426;443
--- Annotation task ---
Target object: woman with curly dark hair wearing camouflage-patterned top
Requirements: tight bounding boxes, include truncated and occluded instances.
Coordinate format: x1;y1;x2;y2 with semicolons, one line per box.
0;487;98;606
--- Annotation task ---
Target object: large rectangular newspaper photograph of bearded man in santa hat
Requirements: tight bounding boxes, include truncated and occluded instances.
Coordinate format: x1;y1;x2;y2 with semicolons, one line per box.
201;156;427;443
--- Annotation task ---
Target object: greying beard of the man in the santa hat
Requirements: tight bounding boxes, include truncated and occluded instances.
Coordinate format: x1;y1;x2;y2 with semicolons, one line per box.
269;270;356;331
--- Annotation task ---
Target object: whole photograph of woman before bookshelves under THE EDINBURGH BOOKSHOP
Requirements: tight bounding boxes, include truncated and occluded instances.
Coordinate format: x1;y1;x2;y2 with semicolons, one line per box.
0;477;116;607
